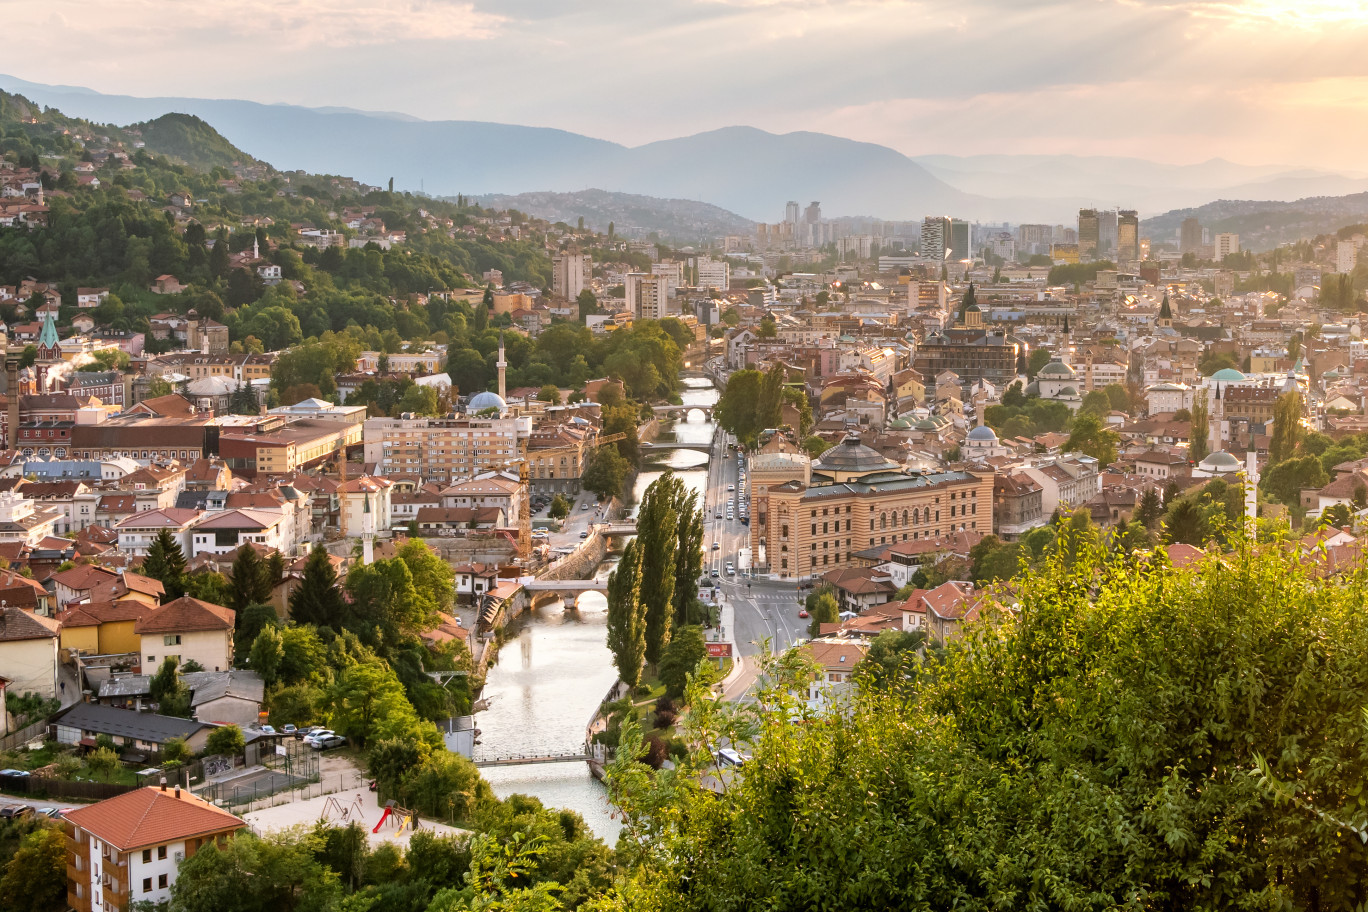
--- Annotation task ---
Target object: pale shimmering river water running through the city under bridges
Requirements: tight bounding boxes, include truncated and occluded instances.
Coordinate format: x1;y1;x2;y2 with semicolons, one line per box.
476;379;718;845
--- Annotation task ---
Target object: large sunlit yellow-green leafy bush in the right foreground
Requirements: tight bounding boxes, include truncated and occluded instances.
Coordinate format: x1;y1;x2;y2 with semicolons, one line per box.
609;543;1368;909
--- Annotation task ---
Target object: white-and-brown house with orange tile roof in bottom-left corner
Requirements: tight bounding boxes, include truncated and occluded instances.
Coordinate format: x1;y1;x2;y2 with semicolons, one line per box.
63;786;245;912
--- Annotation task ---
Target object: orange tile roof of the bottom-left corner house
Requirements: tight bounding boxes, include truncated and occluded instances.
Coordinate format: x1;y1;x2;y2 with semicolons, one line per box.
66;788;245;852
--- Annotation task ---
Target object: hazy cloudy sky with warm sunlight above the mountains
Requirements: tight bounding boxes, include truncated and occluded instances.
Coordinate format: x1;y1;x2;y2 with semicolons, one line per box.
10;0;1368;171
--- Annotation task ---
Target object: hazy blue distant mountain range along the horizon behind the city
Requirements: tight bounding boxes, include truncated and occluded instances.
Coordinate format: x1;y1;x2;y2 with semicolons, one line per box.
8;75;1368;237
